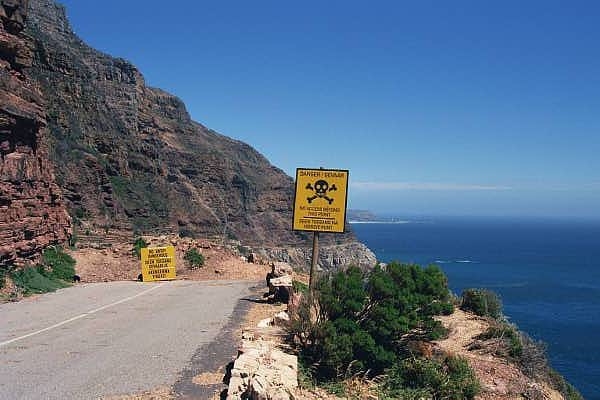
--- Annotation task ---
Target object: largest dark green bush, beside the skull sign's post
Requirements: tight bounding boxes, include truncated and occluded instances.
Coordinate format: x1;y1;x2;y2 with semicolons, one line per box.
288;263;452;381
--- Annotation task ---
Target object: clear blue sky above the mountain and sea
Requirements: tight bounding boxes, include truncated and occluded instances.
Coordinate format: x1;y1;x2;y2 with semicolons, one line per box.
57;0;600;217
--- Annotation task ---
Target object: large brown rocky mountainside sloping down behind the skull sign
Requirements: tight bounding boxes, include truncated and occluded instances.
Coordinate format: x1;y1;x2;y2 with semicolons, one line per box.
18;0;374;268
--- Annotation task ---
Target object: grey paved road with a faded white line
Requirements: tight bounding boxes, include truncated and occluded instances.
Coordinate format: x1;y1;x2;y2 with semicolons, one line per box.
0;281;255;400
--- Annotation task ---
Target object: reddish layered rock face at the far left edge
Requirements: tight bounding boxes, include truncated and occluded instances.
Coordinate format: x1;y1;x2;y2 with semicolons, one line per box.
0;0;71;266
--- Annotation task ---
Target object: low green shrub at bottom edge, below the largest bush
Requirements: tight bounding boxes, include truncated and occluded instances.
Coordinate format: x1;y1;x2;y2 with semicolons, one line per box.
381;356;481;400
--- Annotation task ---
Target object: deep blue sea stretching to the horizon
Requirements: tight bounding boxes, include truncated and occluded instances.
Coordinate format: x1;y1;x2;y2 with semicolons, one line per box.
352;218;600;400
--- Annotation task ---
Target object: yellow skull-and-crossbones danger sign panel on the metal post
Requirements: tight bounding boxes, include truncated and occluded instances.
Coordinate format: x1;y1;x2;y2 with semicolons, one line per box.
293;168;348;233
